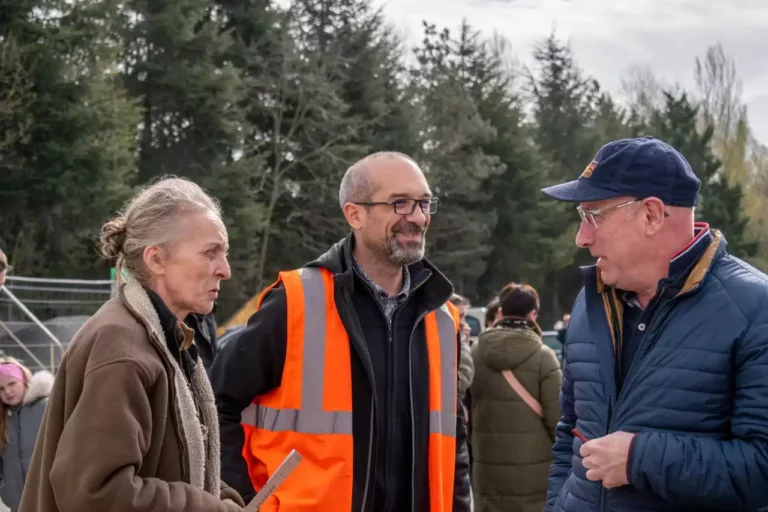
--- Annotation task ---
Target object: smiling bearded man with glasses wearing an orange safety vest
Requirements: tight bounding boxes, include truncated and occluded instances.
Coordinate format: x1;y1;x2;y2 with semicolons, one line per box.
211;152;470;512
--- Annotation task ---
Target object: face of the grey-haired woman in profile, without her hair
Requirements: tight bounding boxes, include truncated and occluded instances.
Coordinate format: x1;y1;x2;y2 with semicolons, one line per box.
145;212;231;320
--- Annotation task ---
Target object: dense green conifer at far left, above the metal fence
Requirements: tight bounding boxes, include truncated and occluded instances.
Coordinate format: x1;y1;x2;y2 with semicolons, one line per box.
0;0;137;278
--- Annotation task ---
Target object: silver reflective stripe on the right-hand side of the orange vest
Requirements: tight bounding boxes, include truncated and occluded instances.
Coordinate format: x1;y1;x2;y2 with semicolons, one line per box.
429;306;459;437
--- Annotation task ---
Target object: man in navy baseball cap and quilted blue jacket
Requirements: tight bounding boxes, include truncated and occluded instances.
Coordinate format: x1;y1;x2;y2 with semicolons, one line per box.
542;137;768;512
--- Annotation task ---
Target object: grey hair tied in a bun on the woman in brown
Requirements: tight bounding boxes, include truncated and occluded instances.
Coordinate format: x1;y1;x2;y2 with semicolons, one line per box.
100;176;225;285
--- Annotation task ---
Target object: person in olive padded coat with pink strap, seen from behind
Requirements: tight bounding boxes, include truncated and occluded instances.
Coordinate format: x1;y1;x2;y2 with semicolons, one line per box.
470;283;562;512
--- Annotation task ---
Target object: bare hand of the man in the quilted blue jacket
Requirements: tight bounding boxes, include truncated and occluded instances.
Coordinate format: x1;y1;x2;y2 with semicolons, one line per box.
580;432;635;489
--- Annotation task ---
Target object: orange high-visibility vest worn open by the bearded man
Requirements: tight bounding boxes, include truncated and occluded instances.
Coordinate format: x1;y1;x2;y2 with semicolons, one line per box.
242;268;459;512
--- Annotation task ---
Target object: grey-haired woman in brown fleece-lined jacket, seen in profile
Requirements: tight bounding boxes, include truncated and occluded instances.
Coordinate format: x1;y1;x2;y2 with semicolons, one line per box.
20;178;242;512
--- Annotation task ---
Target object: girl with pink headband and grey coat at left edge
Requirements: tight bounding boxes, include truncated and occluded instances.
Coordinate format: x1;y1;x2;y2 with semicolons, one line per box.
0;357;53;512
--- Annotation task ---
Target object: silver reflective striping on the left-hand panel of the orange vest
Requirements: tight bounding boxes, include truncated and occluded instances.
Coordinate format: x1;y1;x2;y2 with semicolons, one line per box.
241;268;352;435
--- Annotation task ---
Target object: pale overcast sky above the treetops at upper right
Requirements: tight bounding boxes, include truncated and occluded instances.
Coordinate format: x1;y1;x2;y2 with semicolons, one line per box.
373;0;768;144
